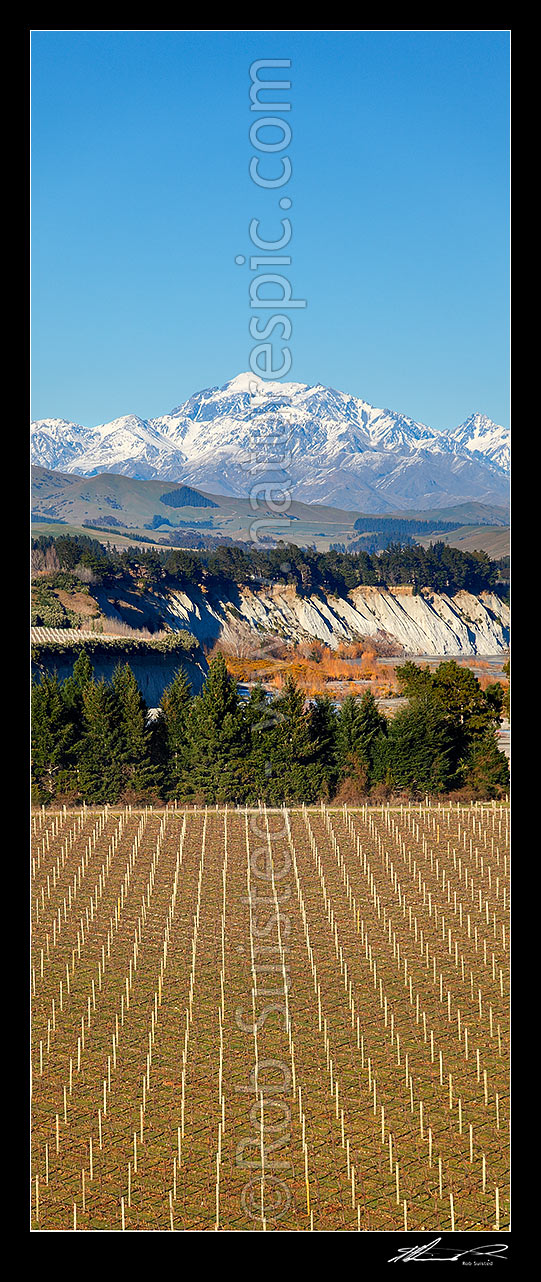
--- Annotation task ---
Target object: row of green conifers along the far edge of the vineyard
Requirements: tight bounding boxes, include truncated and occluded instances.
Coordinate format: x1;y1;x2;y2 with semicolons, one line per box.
32;650;509;805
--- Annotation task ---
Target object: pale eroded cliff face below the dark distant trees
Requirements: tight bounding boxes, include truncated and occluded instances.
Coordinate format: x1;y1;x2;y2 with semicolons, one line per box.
162;586;509;655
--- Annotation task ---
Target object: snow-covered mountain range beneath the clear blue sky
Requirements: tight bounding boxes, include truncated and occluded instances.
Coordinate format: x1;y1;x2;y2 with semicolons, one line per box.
32;373;509;513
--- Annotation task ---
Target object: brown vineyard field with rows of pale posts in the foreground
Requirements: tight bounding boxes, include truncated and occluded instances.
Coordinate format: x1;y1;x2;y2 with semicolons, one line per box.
31;803;510;1231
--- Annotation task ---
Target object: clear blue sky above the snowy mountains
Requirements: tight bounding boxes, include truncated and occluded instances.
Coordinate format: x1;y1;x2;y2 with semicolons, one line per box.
32;31;509;428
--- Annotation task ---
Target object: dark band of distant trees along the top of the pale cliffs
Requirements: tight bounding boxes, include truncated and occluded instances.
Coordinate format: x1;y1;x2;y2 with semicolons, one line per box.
32;535;500;595
